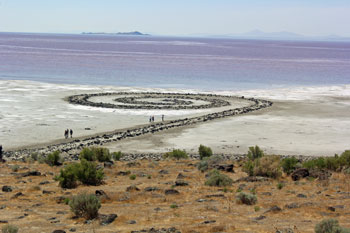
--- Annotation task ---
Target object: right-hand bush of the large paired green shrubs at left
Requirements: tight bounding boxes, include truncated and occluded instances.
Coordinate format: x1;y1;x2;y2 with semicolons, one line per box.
77;159;104;185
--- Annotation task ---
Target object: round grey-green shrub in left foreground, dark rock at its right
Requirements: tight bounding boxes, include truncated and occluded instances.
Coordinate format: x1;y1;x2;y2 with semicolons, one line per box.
69;193;101;219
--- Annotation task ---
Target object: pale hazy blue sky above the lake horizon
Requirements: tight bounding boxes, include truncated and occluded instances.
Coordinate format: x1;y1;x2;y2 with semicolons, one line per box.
0;0;350;36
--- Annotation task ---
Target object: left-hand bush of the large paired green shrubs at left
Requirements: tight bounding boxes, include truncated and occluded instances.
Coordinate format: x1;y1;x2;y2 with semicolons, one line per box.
57;163;80;189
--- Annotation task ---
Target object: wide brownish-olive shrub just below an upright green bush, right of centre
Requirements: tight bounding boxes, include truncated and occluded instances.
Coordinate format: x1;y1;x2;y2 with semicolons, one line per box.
243;155;282;179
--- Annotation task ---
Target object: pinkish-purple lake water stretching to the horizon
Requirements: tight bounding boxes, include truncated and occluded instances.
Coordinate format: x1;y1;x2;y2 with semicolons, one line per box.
0;33;350;90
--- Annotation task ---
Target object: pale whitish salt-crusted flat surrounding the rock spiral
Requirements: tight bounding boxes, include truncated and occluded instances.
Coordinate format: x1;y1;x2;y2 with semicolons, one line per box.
0;81;350;156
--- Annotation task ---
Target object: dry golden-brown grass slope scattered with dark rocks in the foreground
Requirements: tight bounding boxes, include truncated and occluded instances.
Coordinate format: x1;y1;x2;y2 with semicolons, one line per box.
0;160;350;233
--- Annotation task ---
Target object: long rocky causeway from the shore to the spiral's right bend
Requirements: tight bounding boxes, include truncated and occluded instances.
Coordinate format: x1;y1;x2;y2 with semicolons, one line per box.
4;93;273;160
